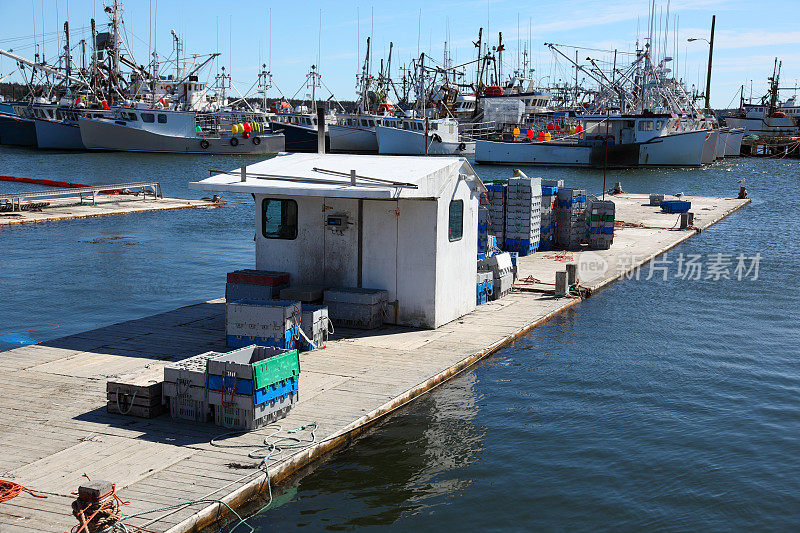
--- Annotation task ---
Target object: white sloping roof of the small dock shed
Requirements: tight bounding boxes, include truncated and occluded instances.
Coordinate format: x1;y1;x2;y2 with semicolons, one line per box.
189;153;485;199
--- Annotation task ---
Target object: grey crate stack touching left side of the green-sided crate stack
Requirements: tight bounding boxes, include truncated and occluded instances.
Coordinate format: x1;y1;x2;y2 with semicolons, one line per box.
161;352;220;422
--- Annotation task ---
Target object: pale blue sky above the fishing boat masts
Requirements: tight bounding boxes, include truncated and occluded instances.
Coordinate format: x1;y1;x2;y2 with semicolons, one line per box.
0;0;800;107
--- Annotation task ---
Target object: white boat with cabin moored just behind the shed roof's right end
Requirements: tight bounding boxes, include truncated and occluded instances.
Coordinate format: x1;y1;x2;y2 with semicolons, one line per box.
375;118;475;156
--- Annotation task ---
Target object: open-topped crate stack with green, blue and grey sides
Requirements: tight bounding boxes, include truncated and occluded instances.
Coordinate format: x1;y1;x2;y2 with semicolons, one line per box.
206;346;300;430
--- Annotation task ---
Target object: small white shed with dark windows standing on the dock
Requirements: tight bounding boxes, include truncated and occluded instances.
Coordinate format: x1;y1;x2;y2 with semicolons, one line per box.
189;154;486;328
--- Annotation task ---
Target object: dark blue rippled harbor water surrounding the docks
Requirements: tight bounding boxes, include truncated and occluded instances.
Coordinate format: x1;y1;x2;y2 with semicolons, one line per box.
0;146;800;531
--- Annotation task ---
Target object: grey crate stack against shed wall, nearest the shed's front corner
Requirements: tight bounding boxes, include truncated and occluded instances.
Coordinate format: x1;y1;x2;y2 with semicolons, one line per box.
325;287;389;329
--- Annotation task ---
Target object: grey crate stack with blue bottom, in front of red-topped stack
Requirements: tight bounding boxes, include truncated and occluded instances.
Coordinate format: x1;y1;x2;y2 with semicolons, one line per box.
225;300;301;349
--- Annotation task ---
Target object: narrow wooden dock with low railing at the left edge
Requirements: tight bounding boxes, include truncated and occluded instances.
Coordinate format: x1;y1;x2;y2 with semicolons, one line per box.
0;194;221;226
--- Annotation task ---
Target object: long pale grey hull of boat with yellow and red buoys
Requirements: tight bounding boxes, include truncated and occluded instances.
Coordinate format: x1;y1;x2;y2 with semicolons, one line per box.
78;118;284;154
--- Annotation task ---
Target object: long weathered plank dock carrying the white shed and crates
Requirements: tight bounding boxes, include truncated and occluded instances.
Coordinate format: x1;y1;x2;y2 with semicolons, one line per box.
0;194;749;533
